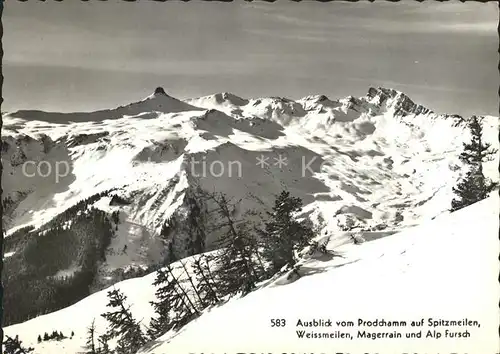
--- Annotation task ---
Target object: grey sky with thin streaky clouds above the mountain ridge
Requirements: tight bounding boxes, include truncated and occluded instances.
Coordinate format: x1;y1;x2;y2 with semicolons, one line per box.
2;0;499;115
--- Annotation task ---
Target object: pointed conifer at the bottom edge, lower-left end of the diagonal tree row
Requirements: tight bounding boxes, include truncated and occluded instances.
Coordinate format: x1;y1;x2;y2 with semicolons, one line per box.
101;289;146;354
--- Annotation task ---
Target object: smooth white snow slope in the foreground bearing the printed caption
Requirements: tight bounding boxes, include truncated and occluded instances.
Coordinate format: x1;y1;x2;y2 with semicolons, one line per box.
5;195;500;354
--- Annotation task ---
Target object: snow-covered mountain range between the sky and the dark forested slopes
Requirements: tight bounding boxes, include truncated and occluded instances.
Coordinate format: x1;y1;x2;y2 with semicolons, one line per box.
2;88;498;238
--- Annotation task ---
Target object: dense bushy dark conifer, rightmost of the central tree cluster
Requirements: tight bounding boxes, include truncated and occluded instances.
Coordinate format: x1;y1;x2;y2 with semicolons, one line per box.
260;191;314;274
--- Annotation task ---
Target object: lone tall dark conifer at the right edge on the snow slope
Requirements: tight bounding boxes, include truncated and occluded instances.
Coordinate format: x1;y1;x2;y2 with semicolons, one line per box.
451;116;497;211
